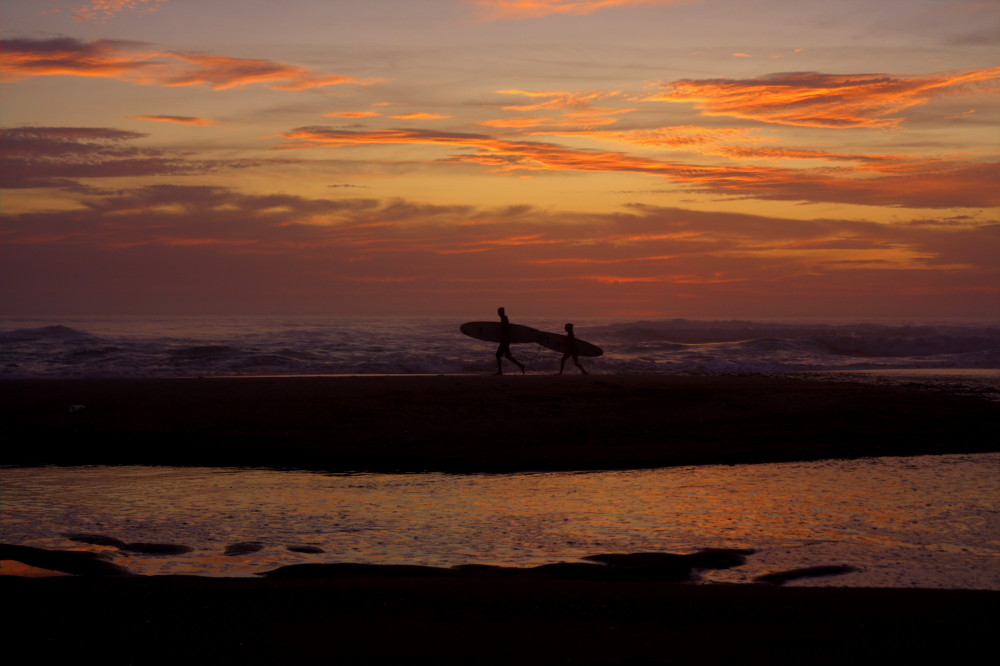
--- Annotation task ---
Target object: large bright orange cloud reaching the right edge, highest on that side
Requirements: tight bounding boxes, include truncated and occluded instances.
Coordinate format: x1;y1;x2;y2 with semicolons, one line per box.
649;67;1000;128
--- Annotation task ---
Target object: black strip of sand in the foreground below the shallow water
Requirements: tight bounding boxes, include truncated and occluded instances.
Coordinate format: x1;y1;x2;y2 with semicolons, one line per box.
0;575;1000;665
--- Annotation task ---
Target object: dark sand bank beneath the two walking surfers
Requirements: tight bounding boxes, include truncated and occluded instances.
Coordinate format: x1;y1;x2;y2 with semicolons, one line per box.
0;375;1000;471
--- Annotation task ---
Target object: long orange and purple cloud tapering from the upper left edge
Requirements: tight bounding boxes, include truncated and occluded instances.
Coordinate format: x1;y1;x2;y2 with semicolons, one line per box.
0;37;377;90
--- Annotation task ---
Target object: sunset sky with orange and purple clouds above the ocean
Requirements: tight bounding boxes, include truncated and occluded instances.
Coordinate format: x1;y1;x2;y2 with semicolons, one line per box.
0;0;1000;322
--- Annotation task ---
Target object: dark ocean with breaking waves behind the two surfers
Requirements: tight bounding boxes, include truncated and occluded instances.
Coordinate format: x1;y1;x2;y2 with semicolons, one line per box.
0;316;1000;392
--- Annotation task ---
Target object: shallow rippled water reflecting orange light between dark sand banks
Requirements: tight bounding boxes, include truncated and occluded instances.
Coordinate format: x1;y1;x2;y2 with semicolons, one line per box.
0;454;1000;590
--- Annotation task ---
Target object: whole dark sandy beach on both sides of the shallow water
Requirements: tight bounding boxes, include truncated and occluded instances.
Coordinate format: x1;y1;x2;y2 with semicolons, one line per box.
0;375;1000;664
